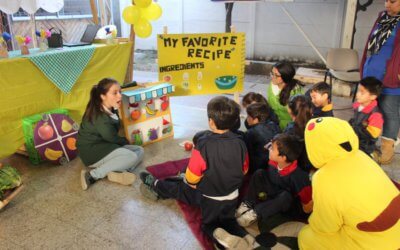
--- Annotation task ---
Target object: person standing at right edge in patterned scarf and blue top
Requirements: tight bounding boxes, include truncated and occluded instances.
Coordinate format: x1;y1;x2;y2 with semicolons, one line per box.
360;0;400;164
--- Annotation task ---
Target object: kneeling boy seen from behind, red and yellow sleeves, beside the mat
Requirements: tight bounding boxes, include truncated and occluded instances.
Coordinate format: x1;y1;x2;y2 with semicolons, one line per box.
140;96;254;248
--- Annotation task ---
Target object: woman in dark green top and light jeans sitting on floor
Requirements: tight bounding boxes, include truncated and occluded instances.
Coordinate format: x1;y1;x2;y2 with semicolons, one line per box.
77;78;144;190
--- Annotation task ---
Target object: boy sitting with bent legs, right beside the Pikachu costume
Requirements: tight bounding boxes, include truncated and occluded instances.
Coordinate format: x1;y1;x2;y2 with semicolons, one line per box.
235;134;312;227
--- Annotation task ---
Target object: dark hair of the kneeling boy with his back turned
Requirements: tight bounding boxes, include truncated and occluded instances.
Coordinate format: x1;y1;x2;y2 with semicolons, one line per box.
207;96;240;130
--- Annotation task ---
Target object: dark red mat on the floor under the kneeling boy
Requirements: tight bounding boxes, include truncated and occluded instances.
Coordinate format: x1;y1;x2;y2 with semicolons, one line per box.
146;158;213;250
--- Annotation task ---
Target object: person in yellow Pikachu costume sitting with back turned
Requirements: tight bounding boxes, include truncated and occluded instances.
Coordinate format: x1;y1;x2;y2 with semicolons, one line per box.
299;117;400;250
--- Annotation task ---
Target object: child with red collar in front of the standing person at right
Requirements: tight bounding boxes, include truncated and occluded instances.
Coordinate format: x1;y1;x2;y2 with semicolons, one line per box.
349;77;383;156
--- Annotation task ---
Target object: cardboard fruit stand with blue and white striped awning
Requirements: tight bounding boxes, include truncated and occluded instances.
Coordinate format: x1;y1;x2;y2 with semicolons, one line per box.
121;83;175;146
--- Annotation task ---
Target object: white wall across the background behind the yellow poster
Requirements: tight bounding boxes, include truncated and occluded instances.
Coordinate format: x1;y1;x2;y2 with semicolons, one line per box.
120;0;384;62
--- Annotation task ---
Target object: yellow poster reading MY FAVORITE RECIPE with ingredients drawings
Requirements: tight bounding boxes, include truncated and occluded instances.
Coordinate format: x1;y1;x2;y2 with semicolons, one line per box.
157;33;245;95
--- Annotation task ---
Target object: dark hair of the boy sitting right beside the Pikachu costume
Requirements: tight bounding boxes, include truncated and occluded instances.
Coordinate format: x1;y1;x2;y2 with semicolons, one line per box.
272;134;304;162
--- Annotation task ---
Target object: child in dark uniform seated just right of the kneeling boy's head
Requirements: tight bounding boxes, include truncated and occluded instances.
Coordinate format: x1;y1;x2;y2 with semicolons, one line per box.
244;103;280;174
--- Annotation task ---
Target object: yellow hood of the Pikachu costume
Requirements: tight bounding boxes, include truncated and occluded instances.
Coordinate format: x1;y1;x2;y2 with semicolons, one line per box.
305;117;358;168
